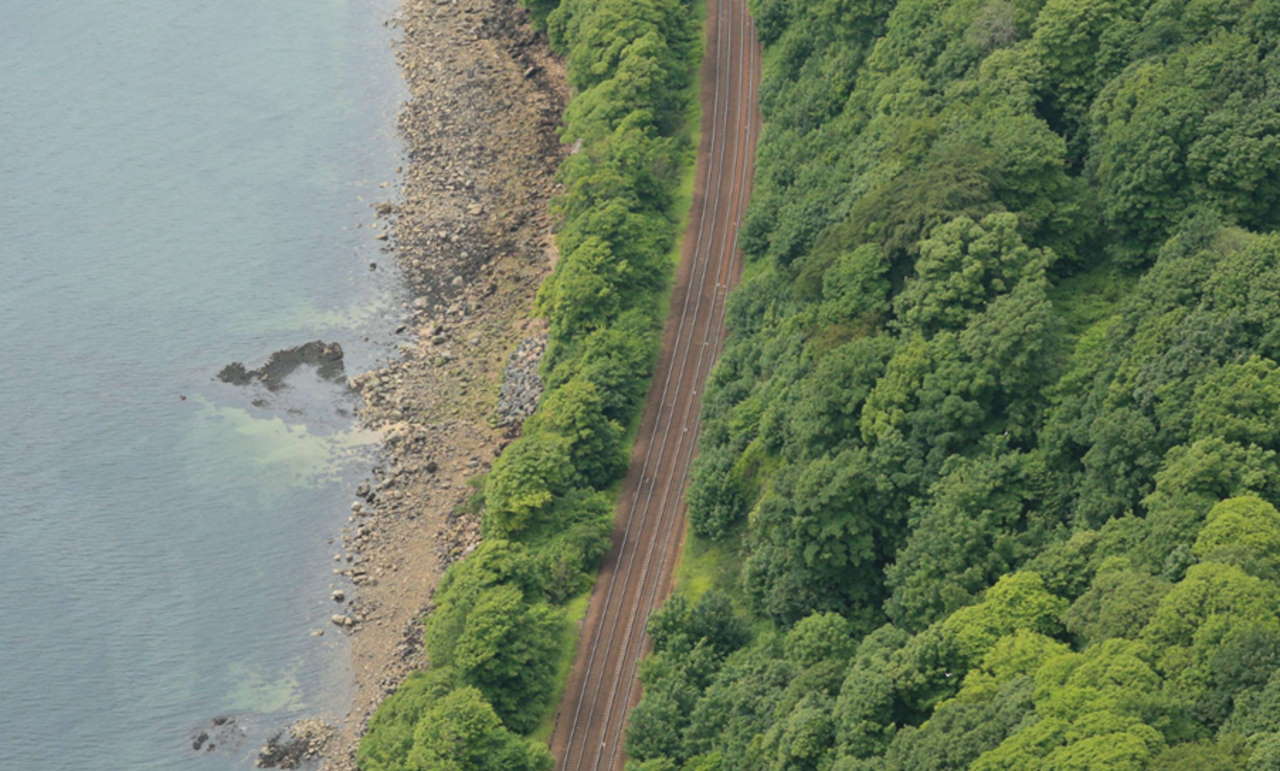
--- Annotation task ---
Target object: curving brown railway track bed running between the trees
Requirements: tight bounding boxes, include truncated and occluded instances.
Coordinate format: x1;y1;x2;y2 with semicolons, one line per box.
552;0;760;771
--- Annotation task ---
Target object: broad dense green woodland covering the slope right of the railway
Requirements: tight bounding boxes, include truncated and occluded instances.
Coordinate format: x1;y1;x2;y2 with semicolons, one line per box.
627;0;1280;771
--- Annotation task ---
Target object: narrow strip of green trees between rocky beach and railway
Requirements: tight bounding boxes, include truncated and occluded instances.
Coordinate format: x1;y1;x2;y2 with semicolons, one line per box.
357;0;701;771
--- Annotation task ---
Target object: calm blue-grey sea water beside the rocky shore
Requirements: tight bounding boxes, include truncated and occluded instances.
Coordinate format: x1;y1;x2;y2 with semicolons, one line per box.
0;0;403;771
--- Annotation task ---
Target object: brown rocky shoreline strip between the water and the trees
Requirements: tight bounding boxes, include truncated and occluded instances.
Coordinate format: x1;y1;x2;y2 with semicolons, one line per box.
323;0;567;771
